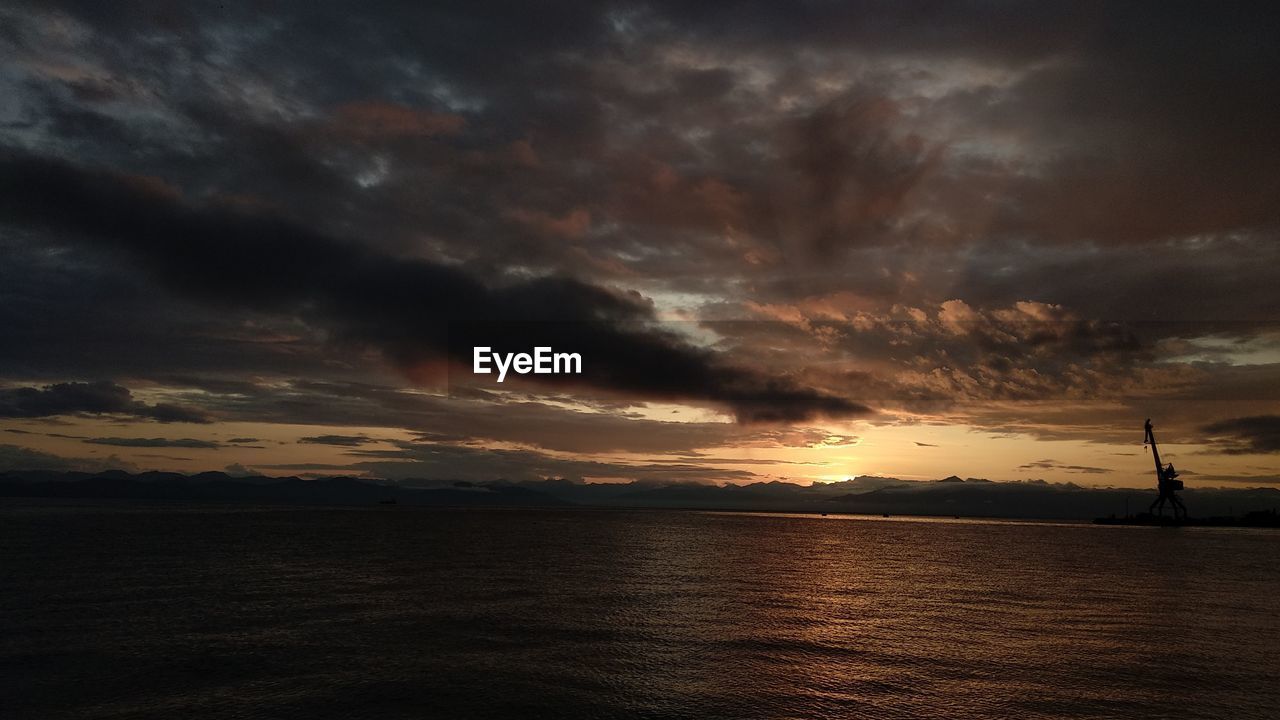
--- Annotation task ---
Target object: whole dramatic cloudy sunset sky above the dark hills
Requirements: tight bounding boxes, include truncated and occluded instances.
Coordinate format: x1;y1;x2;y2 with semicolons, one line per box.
0;1;1280;486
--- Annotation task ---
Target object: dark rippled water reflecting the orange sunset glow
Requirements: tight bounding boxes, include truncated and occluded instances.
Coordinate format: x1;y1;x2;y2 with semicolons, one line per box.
0;501;1280;719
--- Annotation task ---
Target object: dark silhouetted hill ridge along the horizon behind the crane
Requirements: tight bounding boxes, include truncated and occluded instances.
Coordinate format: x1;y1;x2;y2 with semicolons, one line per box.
0;470;1280;520
